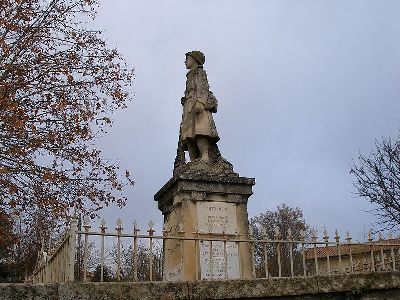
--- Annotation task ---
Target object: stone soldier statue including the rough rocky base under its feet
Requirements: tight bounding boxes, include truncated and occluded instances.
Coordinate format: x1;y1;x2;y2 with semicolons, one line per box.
174;51;233;173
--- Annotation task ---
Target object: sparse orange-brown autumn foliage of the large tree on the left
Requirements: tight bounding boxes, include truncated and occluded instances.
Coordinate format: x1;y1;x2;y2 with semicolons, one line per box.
0;0;133;217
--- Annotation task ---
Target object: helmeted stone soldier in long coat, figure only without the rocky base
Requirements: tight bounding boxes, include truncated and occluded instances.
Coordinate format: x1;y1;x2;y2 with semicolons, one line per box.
180;51;219;162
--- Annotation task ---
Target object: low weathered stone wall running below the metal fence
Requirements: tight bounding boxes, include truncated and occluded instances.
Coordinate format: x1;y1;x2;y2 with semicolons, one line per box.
0;272;400;300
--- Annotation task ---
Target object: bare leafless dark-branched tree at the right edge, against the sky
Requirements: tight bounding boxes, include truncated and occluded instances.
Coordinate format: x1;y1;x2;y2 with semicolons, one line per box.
350;133;400;228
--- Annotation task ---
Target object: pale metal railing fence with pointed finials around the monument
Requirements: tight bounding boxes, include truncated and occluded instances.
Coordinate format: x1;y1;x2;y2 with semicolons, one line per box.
32;217;400;282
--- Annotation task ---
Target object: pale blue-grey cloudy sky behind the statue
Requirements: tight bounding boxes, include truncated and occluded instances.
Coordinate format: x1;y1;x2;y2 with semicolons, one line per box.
87;0;400;239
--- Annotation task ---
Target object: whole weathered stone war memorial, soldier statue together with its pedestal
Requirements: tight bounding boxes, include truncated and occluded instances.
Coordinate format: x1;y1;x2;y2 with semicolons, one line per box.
154;51;255;280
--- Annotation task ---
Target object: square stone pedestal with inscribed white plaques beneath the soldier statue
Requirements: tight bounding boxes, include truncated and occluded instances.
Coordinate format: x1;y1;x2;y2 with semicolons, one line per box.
154;172;255;281
